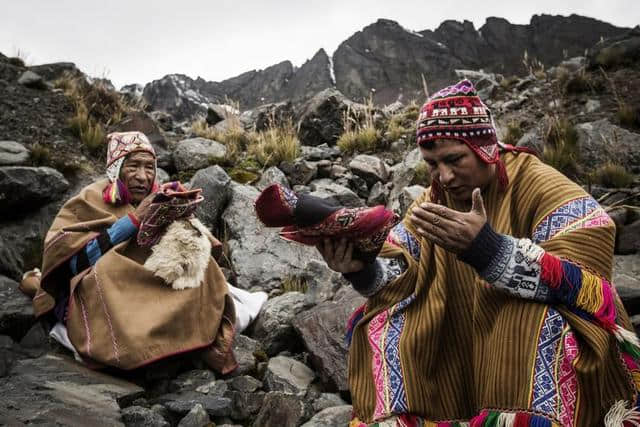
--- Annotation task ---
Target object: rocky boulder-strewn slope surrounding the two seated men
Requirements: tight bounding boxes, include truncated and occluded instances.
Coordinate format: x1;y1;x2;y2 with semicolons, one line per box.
0;24;640;427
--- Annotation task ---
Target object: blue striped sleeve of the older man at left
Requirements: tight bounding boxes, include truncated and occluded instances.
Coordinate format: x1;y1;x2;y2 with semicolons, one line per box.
69;215;139;276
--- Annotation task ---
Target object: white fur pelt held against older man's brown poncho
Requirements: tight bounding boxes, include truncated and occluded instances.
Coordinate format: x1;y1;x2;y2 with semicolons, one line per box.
144;218;211;289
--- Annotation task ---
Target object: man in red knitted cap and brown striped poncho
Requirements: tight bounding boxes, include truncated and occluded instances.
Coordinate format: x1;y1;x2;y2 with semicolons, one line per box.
318;80;640;427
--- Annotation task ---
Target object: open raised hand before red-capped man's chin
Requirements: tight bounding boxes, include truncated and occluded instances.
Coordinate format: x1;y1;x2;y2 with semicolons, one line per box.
411;188;487;254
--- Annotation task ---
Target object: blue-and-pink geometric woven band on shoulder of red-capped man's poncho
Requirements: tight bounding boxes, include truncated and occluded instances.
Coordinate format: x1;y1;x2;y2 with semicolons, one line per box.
532;196;611;243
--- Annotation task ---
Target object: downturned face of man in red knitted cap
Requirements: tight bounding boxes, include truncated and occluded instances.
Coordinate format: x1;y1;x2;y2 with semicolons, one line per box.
420;139;495;203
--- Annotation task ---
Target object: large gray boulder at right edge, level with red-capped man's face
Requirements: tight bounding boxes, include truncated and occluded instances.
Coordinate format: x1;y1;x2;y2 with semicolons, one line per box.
576;119;640;174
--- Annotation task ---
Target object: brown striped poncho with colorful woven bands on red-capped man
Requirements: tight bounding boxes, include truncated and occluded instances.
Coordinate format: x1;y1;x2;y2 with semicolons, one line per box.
348;153;640;427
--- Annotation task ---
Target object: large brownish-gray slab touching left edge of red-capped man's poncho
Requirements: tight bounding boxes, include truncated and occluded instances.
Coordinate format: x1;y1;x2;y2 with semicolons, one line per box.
293;287;366;391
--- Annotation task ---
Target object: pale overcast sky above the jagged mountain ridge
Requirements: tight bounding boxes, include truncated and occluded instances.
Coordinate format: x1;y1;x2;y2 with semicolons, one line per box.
0;0;640;87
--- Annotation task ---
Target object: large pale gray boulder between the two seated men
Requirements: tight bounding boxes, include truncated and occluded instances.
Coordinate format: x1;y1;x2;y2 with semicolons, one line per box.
222;184;320;291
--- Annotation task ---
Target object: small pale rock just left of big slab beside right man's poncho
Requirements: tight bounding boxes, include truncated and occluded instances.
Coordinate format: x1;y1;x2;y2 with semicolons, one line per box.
264;356;315;396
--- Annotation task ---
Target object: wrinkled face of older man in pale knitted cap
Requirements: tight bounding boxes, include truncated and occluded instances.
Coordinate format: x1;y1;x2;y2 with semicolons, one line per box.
120;151;156;205
